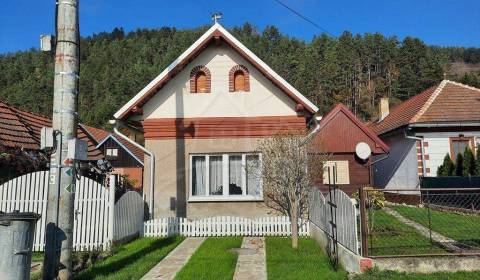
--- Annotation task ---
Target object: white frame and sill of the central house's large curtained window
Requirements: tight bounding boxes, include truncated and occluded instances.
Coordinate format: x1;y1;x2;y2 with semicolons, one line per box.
188;153;263;202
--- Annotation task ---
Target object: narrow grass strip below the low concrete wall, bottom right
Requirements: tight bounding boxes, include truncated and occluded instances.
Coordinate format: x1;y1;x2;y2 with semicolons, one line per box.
353;270;480;280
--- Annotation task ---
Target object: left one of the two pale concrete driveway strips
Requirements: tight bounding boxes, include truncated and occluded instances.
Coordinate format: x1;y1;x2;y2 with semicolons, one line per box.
142;237;205;280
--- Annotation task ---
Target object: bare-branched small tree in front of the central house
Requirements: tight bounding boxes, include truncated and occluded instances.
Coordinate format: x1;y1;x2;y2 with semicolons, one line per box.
253;131;326;248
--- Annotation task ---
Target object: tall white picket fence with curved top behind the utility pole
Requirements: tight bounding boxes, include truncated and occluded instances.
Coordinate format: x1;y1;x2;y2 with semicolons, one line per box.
0;171;143;251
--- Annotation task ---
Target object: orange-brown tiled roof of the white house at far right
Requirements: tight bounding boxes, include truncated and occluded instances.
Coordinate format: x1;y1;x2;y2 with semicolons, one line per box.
370;80;480;135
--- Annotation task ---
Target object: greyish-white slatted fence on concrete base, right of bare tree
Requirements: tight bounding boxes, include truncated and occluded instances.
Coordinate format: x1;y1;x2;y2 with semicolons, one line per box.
309;188;360;254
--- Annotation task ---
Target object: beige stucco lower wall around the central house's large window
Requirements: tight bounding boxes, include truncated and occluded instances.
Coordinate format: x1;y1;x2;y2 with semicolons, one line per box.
144;138;271;218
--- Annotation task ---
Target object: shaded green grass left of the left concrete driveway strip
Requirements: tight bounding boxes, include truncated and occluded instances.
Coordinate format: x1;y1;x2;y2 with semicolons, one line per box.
74;237;184;280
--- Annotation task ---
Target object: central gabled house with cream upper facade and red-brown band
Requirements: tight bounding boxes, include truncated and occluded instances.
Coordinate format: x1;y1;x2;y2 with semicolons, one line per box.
114;23;318;217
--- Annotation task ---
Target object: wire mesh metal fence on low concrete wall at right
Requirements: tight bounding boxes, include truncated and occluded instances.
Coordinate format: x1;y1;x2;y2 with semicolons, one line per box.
359;188;480;257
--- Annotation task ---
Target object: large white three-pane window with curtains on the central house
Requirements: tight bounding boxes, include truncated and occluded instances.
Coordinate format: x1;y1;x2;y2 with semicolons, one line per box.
190;153;262;201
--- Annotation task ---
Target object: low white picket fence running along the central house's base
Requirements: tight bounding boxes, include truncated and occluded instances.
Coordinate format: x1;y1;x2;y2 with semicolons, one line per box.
144;216;310;237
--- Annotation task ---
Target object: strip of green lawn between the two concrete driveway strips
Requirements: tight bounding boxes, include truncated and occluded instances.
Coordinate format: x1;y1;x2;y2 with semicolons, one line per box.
175;237;242;280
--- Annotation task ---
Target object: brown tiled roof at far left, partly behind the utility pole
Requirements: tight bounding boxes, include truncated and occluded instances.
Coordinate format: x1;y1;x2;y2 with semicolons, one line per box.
0;101;103;160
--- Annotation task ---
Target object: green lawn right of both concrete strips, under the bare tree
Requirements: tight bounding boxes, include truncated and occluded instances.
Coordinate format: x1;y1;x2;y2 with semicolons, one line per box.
266;237;347;280
